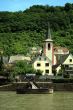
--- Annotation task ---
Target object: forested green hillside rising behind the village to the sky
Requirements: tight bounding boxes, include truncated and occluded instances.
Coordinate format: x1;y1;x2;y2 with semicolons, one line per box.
0;3;73;55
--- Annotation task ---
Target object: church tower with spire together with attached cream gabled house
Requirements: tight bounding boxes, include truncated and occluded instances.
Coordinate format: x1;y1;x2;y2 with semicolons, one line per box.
33;24;53;75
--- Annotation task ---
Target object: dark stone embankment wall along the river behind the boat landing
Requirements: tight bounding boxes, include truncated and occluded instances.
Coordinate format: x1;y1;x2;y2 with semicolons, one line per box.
0;82;73;91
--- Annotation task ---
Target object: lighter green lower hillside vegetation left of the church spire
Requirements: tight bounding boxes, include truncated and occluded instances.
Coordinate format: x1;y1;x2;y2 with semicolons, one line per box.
0;32;43;55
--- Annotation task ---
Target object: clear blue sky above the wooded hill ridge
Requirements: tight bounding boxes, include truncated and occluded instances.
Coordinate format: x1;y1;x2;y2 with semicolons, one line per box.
0;0;73;12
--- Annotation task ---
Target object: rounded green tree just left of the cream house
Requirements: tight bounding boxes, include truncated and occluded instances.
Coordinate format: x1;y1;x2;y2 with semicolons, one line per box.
12;61;36;76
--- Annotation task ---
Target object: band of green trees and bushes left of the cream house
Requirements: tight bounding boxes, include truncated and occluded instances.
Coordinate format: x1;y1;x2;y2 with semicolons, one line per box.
0;61;42;81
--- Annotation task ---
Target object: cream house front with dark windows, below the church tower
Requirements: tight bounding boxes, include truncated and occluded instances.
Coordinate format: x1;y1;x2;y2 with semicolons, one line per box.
33;57;52;75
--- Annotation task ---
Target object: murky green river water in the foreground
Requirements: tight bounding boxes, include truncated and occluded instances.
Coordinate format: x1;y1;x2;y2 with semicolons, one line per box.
0;92;73;110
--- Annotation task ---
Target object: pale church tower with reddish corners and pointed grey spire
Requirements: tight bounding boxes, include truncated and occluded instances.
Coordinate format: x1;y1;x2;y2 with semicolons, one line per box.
44;23;54;65
